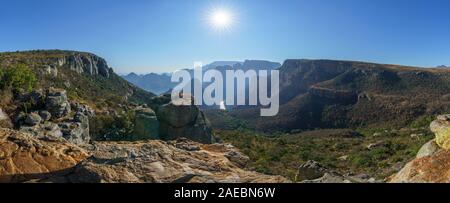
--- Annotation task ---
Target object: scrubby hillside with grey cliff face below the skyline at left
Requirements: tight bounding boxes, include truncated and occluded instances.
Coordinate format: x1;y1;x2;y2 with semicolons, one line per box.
0;50;154;111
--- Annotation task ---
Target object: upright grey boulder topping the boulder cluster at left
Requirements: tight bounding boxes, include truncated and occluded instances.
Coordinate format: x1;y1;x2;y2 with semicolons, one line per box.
45;88;71;118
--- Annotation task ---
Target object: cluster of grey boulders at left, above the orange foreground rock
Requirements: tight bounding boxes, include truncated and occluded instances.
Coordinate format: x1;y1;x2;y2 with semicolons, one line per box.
15;88;95;145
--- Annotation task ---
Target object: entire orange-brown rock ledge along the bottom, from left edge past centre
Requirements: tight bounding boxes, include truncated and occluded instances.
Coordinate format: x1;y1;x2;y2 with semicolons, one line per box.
0;129;289;183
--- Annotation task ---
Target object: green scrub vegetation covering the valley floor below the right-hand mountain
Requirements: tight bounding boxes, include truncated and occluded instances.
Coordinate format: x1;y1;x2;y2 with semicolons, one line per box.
216;116;433;180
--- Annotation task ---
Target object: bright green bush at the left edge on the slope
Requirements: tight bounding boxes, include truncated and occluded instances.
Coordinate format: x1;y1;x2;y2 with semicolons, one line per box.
0;64;37;91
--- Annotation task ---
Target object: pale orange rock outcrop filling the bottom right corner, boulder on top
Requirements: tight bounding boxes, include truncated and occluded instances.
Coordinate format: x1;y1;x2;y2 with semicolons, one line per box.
389;115;450;183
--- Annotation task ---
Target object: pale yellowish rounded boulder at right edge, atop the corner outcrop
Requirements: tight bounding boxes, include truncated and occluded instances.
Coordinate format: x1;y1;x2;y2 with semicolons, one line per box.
430;115;450;149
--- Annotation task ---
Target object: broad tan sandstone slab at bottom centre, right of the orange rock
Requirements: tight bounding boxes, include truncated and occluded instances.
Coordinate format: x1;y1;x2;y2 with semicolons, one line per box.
67;140;289;183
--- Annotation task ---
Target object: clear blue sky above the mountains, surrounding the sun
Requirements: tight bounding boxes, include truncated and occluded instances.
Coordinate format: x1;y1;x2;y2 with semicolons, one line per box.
0;0;450;73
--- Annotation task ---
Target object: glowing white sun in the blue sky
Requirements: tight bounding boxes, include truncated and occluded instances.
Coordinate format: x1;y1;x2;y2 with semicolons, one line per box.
208;9;234;31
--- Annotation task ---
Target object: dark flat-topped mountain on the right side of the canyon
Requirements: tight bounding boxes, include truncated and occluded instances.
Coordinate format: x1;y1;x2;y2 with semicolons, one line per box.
207;60;450;132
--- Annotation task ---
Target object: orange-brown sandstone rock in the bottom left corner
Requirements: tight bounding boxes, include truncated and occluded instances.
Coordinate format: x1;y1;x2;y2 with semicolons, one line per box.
0;129;88;182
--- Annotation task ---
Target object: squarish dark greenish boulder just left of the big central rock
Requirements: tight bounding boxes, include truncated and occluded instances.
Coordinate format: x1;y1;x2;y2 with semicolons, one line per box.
133;107;160;140
